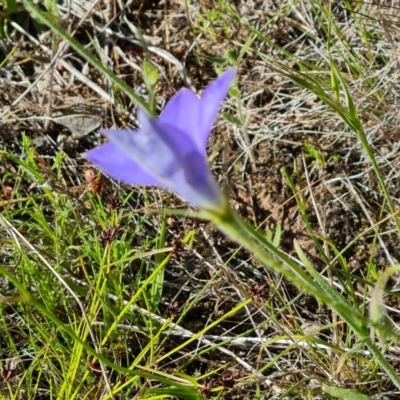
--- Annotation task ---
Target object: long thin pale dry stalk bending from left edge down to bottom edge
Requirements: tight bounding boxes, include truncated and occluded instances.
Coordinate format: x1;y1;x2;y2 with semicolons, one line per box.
0;214;114;398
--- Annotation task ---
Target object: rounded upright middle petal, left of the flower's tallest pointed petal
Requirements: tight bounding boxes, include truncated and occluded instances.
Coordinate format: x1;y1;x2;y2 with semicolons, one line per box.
160;88;202;152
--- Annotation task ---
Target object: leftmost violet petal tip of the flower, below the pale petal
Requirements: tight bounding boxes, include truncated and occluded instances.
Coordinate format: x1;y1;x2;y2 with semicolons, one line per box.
84;143;160;186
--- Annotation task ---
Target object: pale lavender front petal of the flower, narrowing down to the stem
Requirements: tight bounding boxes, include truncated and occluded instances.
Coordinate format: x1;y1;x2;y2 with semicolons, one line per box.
103;109;224;209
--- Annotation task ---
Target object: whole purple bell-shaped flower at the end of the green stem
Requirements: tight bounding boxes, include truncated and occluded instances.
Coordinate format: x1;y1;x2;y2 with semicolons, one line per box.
85;68;236;211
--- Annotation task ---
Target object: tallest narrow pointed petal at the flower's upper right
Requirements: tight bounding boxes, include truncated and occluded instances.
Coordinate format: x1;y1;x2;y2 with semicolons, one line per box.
200;68;236;144
